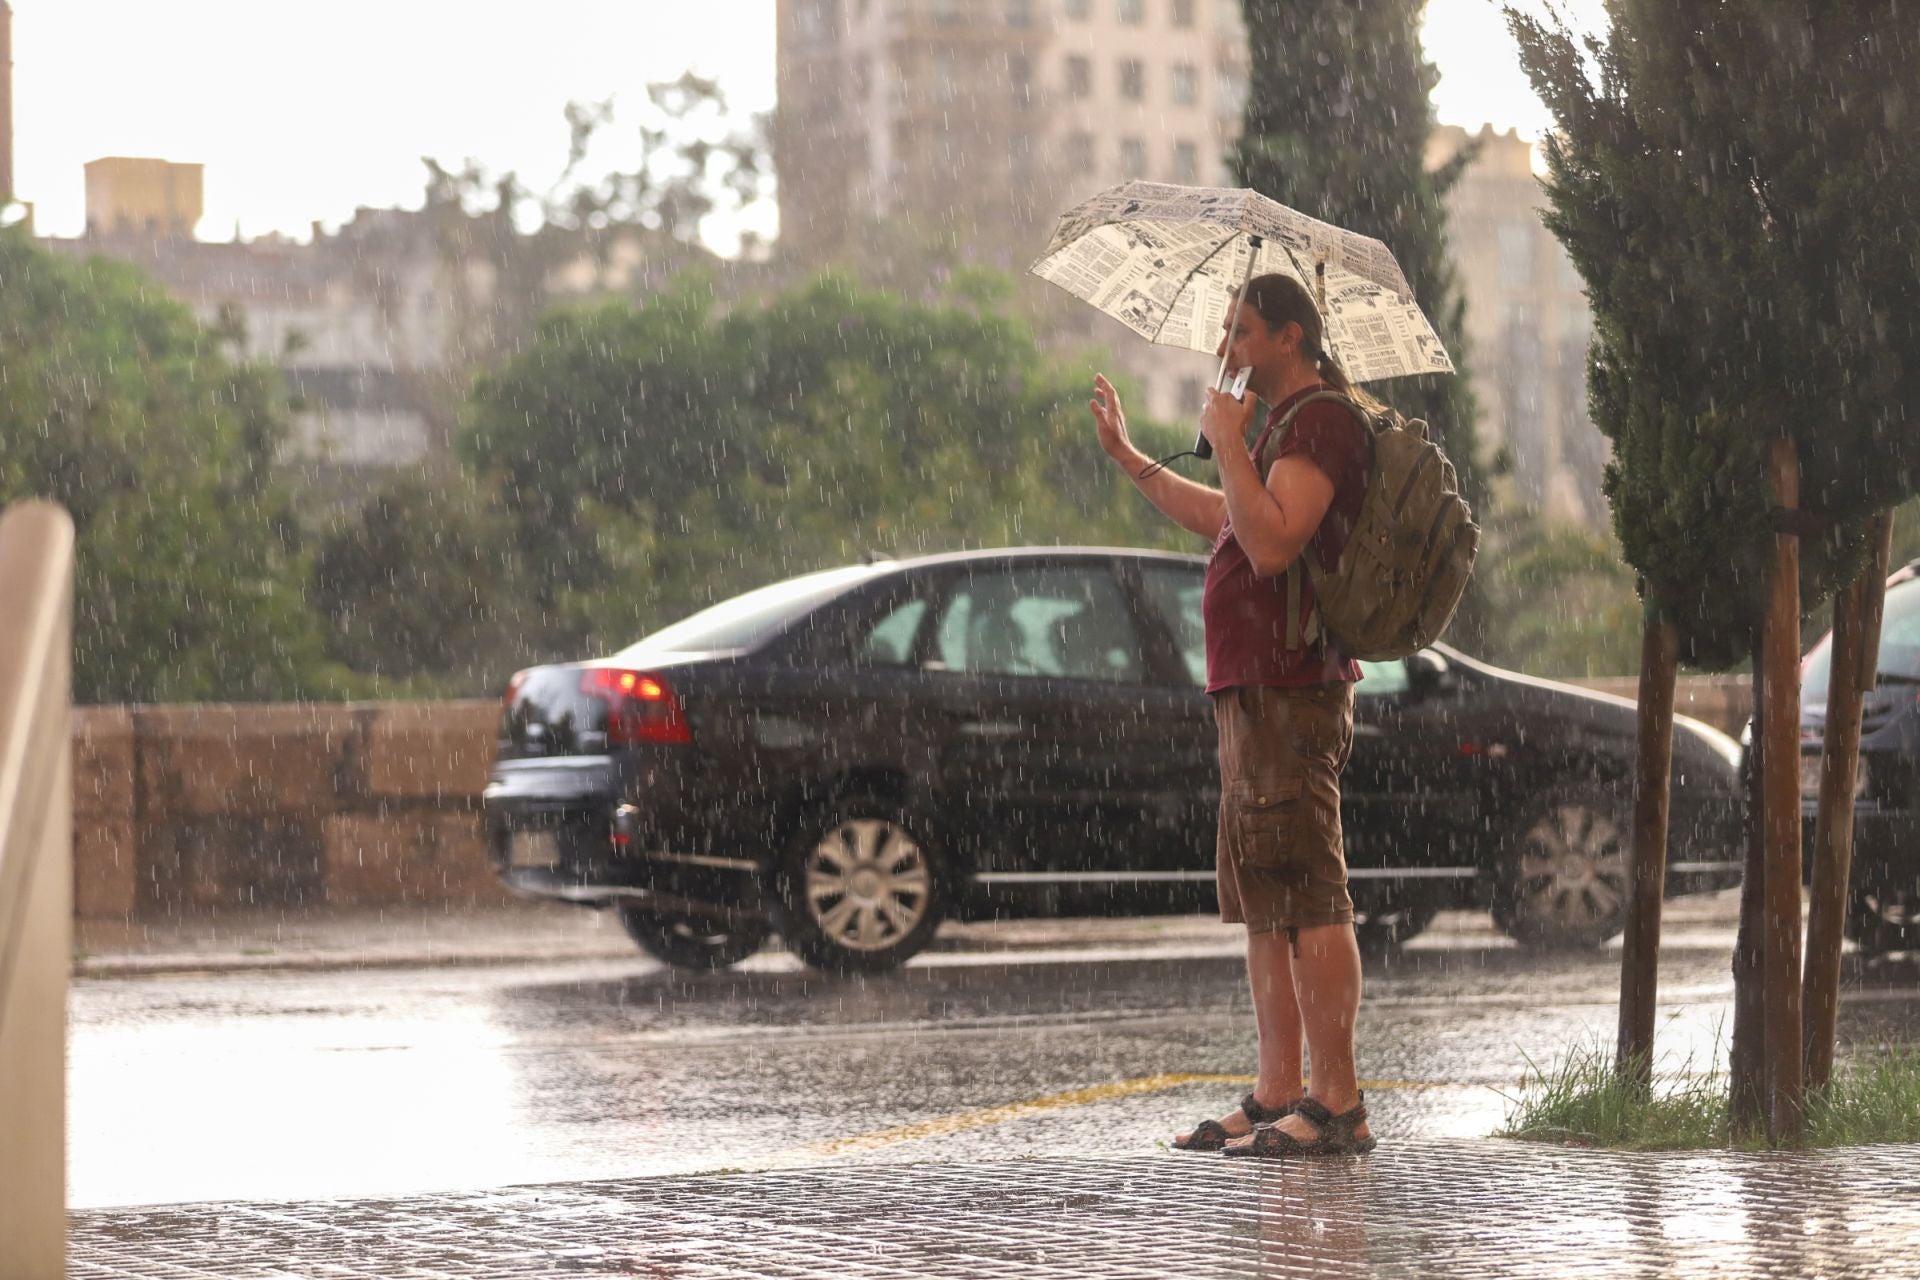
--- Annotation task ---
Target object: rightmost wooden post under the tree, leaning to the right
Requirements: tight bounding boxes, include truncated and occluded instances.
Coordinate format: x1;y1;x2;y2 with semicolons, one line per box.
1801;512;1893;1088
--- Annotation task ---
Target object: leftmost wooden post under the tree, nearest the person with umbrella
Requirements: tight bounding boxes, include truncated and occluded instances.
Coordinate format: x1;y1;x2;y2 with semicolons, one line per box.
1615;606;1680;1092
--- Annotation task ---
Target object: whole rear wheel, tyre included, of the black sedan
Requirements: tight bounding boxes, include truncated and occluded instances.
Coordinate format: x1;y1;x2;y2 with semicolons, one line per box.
778;796;947;973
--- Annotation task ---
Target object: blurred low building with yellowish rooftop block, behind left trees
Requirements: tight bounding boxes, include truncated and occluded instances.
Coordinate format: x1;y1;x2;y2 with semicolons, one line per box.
40;185;721;503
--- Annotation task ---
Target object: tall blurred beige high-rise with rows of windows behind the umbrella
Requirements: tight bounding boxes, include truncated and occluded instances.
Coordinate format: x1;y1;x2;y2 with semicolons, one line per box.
774;0;1246;418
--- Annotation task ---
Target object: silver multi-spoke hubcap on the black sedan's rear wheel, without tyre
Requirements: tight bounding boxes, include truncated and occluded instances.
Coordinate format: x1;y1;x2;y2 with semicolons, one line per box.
806;818;931;952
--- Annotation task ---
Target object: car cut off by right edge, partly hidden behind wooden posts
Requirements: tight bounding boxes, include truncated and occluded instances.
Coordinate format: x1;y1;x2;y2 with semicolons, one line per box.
1801;560;1920;954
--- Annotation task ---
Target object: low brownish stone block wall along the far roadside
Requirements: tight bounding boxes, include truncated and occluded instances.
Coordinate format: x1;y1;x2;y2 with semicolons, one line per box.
73;677;1749;919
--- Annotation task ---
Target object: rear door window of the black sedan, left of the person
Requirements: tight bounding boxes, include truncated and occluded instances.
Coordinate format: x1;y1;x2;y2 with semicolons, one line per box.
935;566;1146;683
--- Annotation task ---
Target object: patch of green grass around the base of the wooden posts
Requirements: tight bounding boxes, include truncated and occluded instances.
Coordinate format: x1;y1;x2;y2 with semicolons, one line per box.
1494;1044;1920;1151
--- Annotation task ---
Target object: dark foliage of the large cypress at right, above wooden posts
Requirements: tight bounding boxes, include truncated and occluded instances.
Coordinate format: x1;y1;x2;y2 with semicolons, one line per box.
1509;0;1920;668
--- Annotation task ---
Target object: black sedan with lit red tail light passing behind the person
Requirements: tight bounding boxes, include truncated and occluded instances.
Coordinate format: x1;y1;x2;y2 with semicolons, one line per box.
486;549;1738;971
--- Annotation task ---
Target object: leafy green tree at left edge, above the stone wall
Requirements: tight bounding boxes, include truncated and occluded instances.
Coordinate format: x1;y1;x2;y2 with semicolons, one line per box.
0;230;342;702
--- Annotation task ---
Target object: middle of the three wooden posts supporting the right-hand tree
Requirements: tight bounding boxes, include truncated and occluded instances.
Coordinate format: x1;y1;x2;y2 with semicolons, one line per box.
1761;439;1807;1146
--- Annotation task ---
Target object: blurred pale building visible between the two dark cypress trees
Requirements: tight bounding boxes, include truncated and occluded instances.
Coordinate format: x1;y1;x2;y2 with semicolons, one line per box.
1428;125;1609;528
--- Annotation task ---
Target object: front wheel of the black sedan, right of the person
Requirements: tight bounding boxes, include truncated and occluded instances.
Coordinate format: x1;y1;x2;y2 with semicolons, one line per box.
1494;793;1632;952
